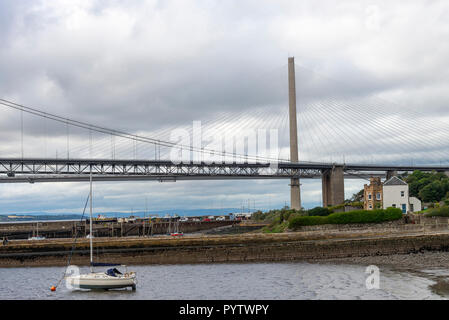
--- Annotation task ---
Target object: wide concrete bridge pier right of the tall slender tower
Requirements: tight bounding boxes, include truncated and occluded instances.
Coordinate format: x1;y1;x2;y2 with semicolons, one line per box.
321;166;345;207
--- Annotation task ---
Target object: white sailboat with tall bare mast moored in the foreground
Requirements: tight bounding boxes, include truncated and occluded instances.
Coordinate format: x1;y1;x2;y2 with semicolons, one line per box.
65;173;137;290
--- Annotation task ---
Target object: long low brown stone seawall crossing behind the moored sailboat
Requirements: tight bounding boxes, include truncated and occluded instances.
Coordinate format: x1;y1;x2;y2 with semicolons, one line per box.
0;232;449;267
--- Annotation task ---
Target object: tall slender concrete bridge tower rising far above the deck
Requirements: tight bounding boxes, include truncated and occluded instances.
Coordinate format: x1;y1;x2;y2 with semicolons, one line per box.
288;57;301;210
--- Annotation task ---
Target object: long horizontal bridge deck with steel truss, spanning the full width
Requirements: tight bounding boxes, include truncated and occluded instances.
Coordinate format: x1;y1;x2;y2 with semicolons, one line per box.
0;158;449;183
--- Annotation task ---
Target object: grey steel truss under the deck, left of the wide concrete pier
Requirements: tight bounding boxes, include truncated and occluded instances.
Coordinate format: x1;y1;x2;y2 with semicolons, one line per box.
0;159;321;182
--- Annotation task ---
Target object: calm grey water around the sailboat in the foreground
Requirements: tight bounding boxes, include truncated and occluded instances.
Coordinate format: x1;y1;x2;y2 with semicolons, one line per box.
0;263;449;299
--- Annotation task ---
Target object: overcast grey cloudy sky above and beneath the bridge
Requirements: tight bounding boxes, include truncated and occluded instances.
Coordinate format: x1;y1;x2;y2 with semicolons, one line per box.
0;0;449;213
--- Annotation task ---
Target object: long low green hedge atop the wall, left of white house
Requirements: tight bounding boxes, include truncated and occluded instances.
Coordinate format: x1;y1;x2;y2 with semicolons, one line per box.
288;208;402;229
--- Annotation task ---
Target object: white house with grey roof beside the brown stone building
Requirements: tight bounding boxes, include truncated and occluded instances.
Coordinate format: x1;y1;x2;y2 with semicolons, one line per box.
382;176;421;213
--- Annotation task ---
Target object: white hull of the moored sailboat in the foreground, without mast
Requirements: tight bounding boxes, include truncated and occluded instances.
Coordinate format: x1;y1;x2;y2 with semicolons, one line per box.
66;273;137;289
